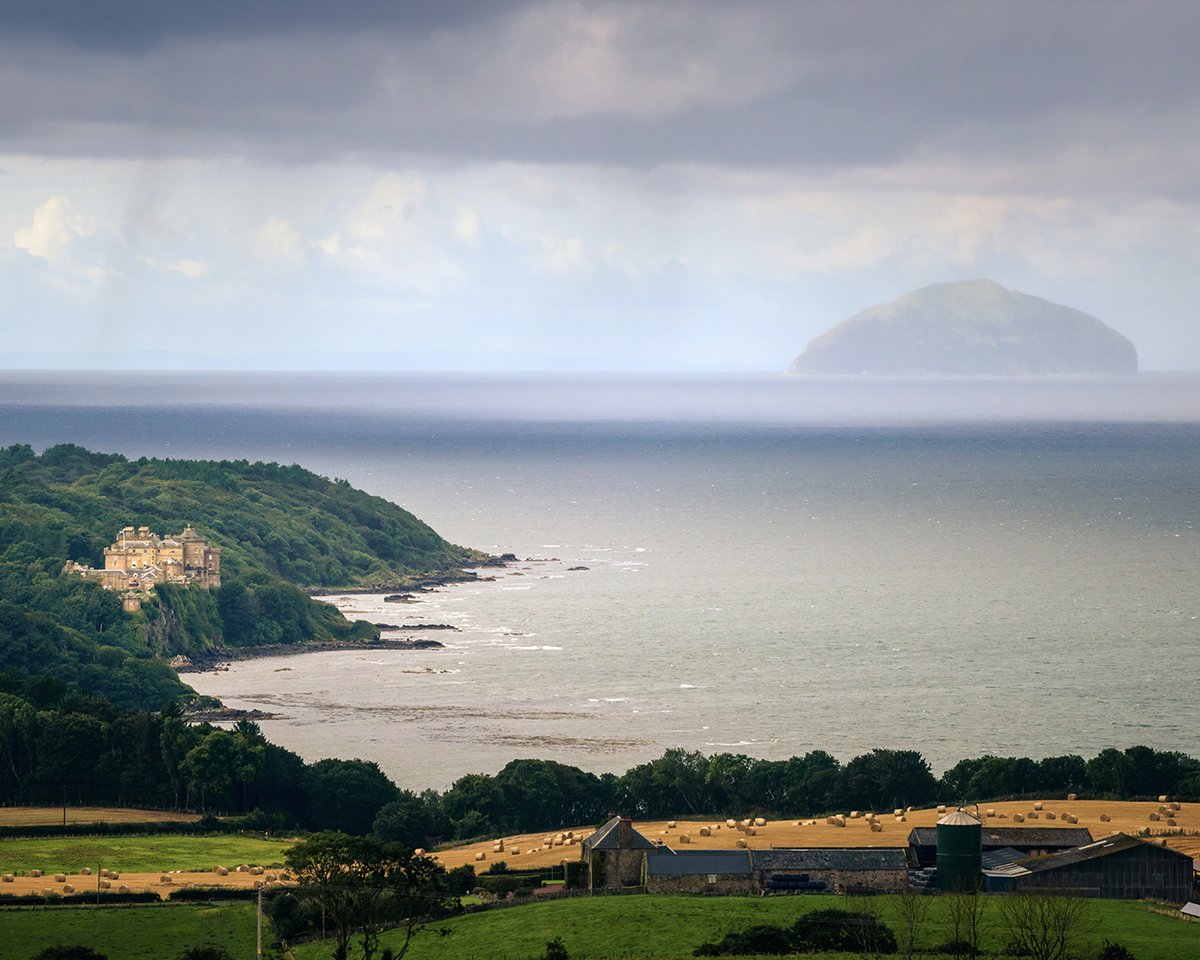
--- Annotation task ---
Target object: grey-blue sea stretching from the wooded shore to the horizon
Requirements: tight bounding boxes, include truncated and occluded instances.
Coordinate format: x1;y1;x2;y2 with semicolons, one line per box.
0;372;1200;790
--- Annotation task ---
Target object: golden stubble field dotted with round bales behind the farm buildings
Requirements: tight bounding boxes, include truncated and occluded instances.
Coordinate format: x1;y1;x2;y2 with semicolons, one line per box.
434;800;1200;872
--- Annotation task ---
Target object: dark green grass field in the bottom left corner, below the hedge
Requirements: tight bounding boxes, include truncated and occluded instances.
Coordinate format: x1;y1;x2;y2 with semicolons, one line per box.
0;904;254;960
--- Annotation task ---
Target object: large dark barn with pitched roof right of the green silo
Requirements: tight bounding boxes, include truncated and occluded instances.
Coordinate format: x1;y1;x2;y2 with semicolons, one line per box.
984;833;1192;904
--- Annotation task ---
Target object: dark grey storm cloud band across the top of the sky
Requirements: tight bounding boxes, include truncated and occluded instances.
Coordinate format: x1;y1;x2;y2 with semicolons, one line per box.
0;0;1200;190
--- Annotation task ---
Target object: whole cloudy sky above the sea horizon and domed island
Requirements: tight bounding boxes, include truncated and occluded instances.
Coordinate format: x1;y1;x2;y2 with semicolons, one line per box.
0;0;1200;371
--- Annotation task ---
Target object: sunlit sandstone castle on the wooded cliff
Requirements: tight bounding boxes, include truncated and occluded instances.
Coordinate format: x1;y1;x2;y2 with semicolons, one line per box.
66;524;221;610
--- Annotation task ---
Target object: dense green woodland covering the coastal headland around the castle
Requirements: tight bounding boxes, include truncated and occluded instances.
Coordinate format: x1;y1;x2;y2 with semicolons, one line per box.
0;444;482;709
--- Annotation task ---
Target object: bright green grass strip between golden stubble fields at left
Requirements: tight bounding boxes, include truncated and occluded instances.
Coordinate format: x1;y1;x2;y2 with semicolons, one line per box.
0;834;290;874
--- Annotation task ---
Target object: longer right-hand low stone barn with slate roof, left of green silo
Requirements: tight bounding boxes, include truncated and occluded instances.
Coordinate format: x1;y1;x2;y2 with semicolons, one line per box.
750;847;908;893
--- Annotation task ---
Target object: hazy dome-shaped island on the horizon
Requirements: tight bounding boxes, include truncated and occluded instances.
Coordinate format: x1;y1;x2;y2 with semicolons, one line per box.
788;280;1138;377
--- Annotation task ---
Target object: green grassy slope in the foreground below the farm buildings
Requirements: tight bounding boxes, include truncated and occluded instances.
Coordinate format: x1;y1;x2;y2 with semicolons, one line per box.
288;895;1200;960
